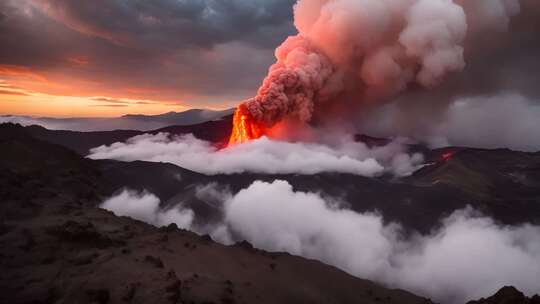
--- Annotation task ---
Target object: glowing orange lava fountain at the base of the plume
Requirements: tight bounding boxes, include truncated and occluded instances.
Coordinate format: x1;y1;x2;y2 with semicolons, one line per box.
229;105;265;146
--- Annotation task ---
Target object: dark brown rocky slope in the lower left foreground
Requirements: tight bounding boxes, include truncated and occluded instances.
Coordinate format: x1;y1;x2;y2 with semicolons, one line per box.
0;125;429;304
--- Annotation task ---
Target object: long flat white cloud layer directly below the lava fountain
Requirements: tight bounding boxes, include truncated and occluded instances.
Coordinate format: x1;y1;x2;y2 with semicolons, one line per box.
88;133;423;176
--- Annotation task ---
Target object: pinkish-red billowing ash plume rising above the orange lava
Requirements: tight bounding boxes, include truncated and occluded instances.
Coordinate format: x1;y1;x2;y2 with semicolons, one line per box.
241;0;520;126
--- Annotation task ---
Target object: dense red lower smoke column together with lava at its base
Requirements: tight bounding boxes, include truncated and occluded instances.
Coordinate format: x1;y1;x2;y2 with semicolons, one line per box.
229;35;341;145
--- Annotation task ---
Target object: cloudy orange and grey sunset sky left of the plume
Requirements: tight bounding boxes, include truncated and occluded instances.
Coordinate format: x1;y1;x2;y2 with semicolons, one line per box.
0;0;294;117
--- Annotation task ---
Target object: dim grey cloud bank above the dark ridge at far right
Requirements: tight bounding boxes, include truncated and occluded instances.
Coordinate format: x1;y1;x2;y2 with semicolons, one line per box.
362;93;540;152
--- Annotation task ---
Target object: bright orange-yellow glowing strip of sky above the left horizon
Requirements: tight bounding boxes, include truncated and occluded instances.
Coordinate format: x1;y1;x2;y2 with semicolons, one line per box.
0;65;227;117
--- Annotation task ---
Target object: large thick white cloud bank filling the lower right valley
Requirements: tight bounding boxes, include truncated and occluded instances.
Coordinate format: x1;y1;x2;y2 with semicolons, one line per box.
101;181;540;304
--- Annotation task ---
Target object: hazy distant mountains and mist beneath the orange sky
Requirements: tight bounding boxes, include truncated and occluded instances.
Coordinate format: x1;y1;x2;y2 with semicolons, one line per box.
0;108;234;132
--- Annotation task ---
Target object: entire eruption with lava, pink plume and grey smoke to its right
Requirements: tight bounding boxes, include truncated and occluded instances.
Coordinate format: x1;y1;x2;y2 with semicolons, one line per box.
218;0;540;151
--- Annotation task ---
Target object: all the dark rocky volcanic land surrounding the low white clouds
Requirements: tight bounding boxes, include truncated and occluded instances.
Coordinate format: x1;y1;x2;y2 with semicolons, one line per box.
0;122;540;304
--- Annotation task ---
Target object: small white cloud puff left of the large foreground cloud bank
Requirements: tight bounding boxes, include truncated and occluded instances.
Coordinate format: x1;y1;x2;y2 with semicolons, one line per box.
101;189;194;229
